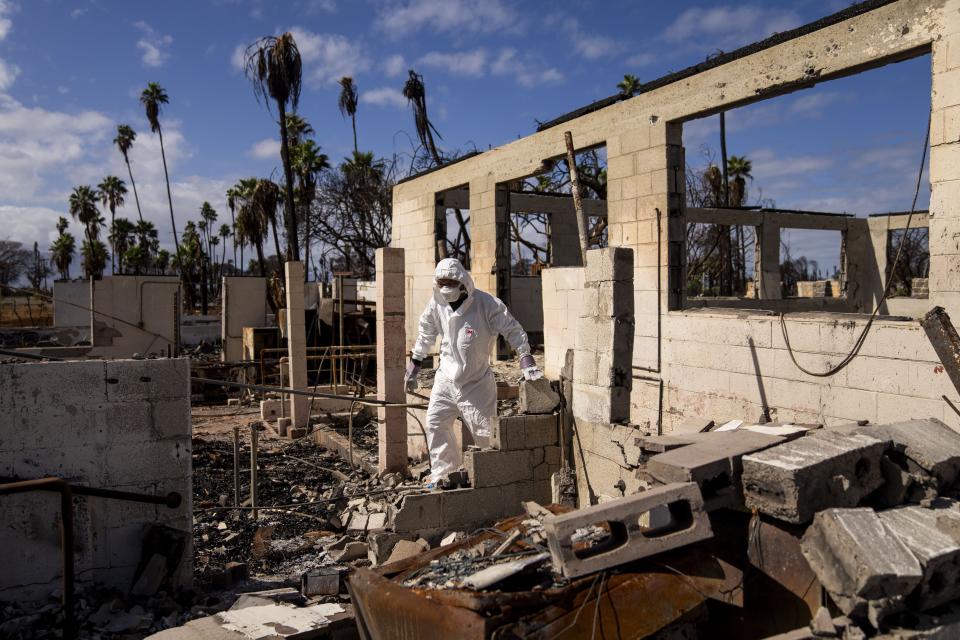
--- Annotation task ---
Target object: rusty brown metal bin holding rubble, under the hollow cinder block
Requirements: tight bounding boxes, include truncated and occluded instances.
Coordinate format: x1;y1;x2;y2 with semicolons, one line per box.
350;505;744;640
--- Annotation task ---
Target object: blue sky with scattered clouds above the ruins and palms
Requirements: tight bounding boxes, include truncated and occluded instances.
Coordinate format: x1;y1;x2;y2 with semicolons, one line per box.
0;0;930;272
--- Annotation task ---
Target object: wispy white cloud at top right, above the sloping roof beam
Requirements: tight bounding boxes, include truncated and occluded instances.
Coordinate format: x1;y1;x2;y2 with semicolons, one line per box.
663;5;802;49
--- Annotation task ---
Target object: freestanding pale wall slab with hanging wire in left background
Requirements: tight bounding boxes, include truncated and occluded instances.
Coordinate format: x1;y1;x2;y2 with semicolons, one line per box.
87;276;182;358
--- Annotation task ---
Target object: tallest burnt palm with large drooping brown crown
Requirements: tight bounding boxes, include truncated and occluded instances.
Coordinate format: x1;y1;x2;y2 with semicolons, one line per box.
245;31;302;261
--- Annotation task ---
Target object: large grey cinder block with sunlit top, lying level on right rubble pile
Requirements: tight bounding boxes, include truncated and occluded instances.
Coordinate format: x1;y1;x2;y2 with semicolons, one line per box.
743;430;889;523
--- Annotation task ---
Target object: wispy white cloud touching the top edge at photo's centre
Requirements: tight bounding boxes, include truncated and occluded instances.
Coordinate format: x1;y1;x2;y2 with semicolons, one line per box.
375;0;520;37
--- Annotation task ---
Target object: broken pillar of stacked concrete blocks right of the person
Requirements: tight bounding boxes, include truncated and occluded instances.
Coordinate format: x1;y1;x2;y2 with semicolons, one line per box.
573;248;634;423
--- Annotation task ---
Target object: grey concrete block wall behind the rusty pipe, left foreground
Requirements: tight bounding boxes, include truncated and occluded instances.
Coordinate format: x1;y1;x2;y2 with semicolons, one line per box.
0;359;193;601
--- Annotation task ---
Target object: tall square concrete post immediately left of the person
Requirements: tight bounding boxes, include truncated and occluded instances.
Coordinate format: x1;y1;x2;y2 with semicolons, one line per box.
376;247;407;473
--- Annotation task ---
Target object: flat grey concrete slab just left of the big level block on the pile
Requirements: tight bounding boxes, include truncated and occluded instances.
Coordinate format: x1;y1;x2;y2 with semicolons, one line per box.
647;431;784;510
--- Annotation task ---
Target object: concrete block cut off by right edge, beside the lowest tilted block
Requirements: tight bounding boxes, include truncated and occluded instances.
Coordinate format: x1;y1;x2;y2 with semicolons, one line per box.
877;500;960;610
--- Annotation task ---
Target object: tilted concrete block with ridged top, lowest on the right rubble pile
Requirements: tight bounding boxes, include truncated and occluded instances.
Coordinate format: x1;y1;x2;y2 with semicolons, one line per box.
800;508;923;627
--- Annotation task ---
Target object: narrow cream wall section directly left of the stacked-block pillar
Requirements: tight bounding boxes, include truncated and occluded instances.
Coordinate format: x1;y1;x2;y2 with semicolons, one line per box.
540;267;583;380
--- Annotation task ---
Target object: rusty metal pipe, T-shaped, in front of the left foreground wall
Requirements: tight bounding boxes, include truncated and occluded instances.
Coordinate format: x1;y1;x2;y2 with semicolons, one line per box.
0;478;183;639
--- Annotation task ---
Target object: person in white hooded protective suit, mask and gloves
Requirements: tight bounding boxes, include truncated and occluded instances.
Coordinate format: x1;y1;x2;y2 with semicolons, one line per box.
404;258;543;483
